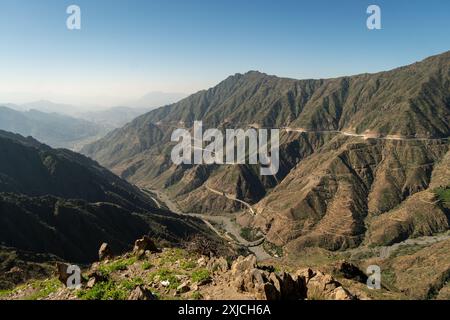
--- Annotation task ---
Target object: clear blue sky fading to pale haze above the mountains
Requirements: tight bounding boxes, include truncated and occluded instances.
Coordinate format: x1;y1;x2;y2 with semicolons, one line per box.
0;0;450;105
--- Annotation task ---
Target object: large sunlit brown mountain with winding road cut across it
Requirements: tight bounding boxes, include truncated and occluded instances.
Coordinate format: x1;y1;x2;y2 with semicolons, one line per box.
83;52;450;252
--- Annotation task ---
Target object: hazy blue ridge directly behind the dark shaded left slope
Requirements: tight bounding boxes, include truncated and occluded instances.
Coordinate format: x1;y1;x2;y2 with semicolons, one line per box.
0;106;107;149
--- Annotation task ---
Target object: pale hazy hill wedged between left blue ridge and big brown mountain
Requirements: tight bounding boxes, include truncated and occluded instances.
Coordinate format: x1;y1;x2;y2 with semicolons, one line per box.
77;107;152;129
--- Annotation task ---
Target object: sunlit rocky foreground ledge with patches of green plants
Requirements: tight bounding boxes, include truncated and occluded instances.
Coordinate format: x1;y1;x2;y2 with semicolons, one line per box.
0;237;357;300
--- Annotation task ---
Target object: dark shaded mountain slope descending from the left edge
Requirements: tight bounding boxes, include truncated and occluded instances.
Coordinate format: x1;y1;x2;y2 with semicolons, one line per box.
0;131;215;262
